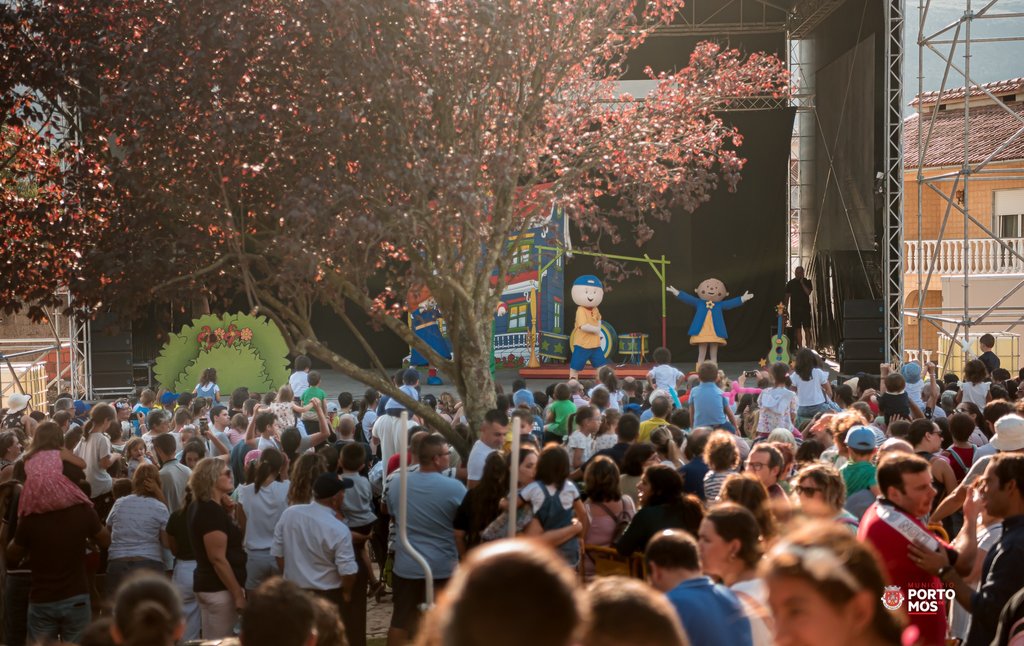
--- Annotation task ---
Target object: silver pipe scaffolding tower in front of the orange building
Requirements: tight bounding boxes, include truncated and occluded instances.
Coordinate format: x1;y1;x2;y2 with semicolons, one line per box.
909;0;1024;370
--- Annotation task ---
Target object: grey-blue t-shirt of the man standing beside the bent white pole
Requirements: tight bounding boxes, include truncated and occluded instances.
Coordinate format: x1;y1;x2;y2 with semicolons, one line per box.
387;471;466;578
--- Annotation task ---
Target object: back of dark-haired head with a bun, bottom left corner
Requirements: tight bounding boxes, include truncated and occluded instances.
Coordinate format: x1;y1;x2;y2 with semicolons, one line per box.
111;574;185;646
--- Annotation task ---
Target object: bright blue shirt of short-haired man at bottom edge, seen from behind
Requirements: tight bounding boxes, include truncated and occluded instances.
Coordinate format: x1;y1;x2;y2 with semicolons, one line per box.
666;576;753;646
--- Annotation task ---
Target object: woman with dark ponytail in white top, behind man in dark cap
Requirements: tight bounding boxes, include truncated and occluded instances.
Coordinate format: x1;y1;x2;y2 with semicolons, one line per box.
234;448;288;591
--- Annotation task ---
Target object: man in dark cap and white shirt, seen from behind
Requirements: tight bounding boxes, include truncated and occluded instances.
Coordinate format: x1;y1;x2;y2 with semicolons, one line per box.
270;472;366;643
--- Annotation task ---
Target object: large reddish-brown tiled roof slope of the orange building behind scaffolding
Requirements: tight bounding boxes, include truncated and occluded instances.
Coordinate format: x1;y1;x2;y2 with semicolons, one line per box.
903;101;1024;168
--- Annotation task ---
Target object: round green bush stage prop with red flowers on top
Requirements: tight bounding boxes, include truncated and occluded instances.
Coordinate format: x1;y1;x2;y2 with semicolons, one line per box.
153;313;289;393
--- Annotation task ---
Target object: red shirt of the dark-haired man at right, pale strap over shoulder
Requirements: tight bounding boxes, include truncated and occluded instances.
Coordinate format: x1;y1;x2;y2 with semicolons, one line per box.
857;502;956;646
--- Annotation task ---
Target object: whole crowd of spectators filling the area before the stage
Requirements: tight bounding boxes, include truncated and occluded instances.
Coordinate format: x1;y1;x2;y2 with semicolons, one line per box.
6;349;1024;646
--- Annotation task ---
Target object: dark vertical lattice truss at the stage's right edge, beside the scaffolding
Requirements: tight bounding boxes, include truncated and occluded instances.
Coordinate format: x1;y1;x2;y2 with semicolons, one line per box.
882;0;905;362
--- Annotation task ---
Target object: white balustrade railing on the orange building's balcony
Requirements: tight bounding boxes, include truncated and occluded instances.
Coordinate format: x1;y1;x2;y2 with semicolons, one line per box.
903;238;1024;276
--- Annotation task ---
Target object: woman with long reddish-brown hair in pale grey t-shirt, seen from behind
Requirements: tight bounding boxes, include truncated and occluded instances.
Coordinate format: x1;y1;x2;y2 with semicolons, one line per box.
106;464;170;598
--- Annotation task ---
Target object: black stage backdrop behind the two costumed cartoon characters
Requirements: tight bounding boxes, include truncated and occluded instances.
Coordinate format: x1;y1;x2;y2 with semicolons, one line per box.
565;109;796;362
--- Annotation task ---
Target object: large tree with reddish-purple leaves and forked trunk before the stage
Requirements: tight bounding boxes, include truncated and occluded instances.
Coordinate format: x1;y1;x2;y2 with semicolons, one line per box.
0;0;786;450
